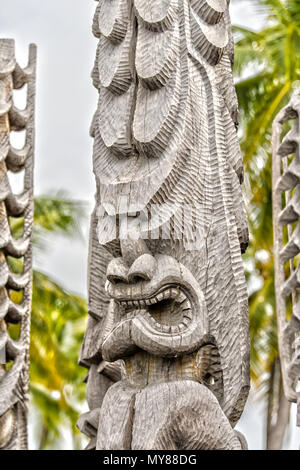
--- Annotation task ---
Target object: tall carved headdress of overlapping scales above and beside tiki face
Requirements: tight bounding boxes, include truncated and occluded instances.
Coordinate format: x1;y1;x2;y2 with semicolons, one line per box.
82;0;249;434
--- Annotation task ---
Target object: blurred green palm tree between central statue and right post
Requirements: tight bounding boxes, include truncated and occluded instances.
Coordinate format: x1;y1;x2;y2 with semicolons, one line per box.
234;0;300;449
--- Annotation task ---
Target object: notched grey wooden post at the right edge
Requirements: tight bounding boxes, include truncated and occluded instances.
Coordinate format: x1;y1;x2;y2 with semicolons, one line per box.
272;96;300;434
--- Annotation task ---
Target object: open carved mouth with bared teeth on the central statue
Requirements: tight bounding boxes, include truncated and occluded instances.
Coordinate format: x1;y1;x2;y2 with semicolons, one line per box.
117;285;192;333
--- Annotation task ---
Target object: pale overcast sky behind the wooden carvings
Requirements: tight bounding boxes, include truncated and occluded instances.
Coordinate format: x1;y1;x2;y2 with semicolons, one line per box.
0;0;300;449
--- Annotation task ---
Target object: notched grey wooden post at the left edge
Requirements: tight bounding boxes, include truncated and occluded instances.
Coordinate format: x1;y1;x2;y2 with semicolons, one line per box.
0;39;36;449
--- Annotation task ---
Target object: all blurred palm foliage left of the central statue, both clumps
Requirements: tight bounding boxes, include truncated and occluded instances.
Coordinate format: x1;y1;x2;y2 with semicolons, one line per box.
10;194;87;449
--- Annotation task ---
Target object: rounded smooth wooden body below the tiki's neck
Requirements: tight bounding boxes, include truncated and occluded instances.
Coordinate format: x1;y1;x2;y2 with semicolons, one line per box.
97;380;242;450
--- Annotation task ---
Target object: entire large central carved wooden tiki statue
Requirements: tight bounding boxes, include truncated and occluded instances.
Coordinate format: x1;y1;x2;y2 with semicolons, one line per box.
78;0;249;450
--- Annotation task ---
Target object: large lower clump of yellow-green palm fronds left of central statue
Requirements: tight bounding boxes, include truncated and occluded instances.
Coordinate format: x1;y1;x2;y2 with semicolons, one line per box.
30;271;87;447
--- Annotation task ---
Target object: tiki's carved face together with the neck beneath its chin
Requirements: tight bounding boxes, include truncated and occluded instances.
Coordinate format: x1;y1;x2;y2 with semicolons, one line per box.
102;239;224;402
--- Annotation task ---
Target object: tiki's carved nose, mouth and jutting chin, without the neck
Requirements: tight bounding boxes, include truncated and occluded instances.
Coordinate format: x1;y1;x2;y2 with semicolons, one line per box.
102;240;208;361
